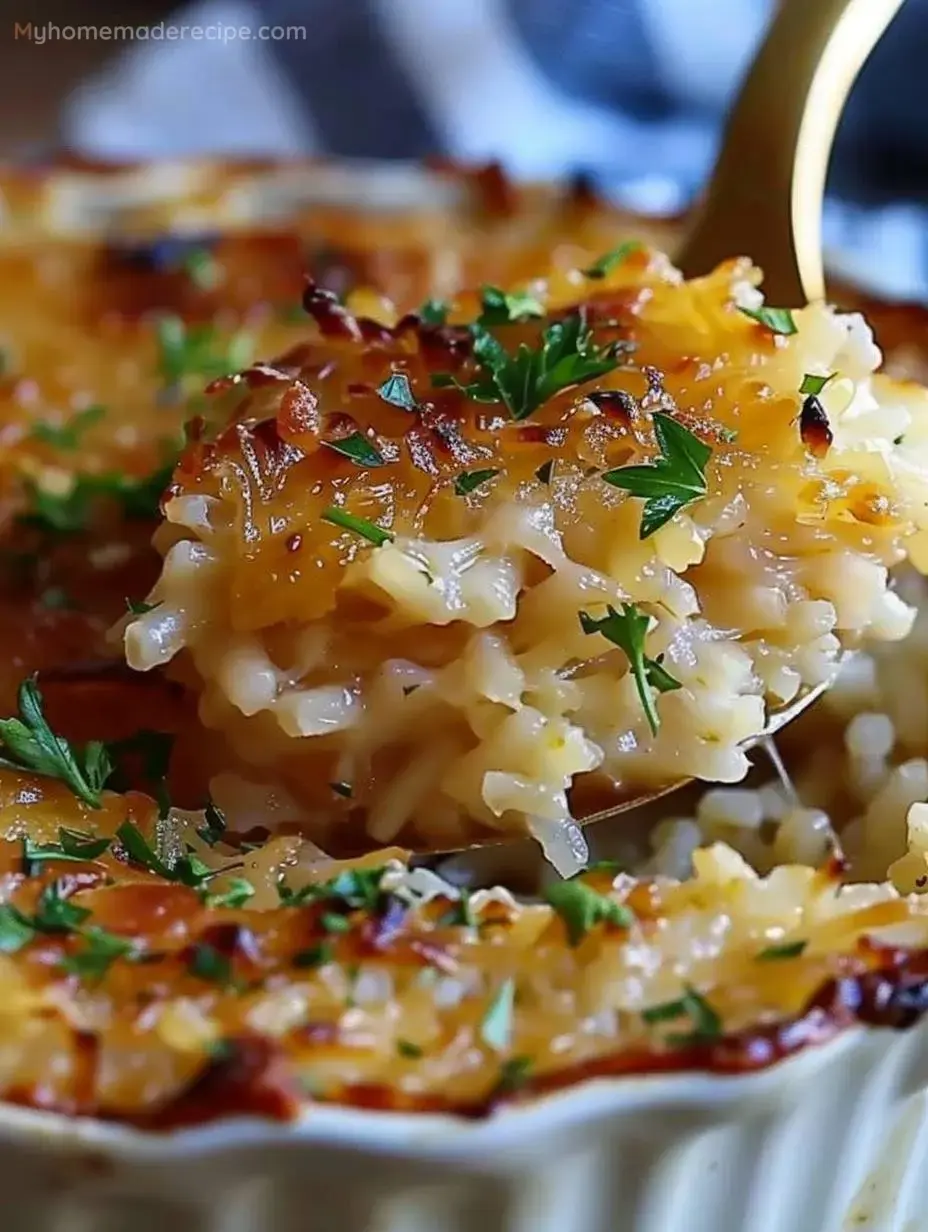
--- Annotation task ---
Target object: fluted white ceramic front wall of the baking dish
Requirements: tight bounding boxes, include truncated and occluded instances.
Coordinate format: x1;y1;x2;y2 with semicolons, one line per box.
0;1026;928;1232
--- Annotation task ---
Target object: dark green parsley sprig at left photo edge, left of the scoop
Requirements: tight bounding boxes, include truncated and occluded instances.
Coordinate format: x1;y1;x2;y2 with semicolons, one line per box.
0;675;113;808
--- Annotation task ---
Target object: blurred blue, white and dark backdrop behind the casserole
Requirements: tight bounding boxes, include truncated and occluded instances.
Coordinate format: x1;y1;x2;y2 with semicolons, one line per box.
0;0;928;298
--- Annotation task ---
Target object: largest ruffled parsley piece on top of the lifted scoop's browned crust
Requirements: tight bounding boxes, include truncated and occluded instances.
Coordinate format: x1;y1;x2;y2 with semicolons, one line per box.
431;309;619;419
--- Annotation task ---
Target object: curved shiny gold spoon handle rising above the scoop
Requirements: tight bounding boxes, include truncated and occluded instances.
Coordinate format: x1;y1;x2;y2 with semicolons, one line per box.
677;0;903;307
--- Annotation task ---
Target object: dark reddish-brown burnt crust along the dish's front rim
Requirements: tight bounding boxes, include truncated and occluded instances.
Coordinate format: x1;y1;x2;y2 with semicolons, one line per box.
2;940;928;1132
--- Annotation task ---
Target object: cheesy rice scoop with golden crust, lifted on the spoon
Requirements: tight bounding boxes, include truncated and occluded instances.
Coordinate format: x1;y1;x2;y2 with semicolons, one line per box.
124;249;928;870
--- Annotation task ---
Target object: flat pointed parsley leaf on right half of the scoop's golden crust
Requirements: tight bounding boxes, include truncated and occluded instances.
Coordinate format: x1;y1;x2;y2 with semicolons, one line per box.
603;411;712;540
